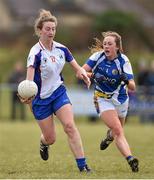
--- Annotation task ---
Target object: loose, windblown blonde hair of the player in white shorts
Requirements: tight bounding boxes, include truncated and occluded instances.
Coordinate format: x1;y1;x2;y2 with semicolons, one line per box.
90;31;123;53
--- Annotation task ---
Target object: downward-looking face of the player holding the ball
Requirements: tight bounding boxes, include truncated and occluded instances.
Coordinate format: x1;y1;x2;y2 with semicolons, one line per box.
40;21;56;40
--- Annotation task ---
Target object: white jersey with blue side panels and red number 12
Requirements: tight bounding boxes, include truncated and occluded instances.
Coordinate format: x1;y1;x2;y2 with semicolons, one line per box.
27;41;74;102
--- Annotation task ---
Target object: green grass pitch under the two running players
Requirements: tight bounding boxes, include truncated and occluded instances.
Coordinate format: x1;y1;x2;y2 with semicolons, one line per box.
0;120;154;179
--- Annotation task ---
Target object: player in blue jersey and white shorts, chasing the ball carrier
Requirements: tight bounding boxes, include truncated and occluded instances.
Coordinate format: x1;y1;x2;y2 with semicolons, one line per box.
83;31;139;172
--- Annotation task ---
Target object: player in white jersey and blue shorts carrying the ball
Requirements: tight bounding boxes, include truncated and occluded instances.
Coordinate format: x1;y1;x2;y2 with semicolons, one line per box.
20;9;90;172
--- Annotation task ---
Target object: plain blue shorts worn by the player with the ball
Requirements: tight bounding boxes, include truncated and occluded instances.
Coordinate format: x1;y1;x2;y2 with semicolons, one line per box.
32;92;71;120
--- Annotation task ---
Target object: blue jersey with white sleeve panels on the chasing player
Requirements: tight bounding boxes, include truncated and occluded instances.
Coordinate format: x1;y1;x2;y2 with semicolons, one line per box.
86;51;134;105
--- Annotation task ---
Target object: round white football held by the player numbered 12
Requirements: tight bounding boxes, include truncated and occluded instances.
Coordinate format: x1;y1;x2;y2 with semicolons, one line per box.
18;80;38;98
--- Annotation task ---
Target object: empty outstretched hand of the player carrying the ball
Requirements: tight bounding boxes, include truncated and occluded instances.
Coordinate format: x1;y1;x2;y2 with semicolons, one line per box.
76;68;91;89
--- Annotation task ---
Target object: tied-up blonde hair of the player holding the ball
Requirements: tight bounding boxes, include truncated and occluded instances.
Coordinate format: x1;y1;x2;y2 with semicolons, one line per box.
34;9;57;36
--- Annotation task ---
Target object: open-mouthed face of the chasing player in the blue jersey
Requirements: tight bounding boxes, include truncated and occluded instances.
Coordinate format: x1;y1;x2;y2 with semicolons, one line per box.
103;36;118;60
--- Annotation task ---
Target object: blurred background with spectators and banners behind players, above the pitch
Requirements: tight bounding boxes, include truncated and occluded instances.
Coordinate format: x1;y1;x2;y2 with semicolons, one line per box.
0;0;154;123
